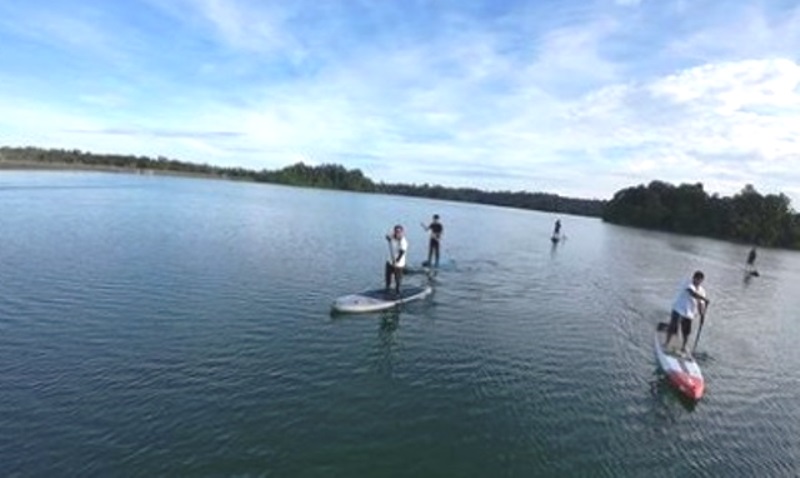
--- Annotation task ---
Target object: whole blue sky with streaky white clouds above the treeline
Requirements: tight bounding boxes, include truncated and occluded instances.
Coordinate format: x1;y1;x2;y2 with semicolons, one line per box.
0;0;800;203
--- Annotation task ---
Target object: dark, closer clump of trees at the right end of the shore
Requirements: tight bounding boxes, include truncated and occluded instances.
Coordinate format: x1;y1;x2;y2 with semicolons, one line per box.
603;181;800;249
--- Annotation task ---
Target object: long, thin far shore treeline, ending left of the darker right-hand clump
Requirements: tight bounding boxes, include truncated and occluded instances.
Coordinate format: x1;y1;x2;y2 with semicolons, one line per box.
0;147;605;217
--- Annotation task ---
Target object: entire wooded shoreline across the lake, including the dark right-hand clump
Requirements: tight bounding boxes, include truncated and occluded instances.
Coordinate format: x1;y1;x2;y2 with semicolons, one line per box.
0;147;800;249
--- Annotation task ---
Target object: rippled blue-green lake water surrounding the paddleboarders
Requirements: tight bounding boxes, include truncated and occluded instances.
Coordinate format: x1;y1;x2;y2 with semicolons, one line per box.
0;172;800;477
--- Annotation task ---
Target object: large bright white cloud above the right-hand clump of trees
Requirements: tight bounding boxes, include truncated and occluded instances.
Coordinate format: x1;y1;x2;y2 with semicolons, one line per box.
554;59;800;203
